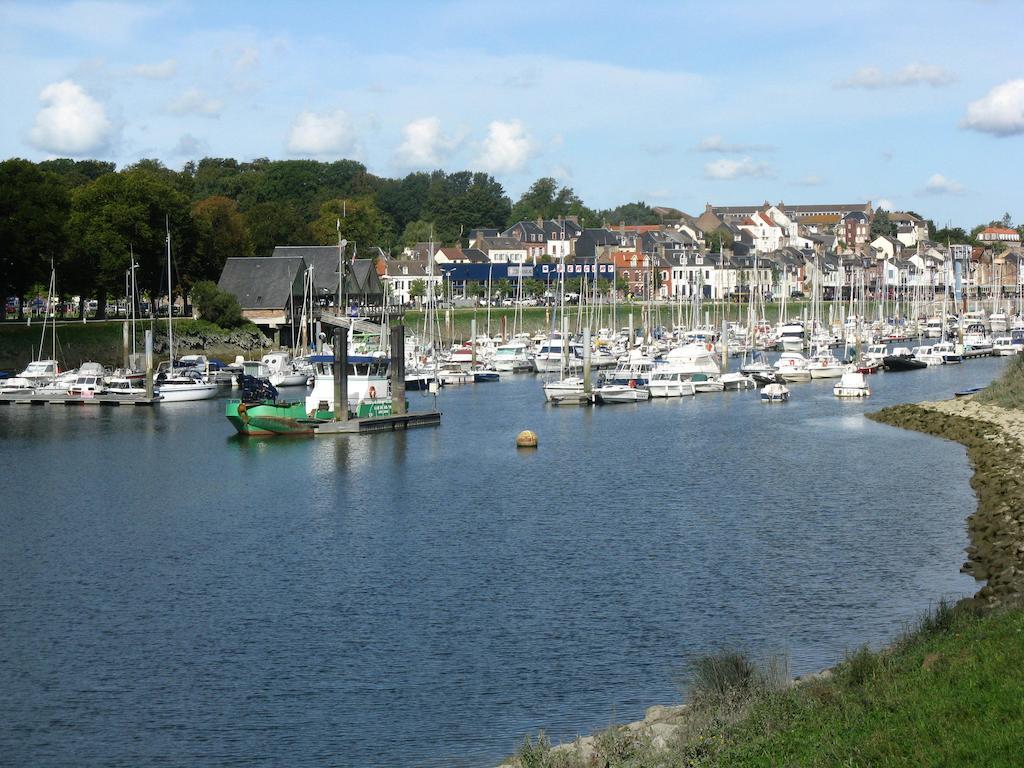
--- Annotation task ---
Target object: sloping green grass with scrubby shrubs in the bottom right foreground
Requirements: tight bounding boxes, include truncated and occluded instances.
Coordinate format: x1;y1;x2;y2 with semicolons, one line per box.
518;603;1024;768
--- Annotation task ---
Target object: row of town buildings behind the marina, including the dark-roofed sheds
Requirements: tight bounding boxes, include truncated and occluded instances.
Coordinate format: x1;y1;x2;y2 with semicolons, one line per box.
220;202;1024;342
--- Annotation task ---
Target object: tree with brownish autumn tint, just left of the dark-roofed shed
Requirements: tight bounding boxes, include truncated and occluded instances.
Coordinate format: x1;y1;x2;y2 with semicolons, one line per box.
188;197;253;290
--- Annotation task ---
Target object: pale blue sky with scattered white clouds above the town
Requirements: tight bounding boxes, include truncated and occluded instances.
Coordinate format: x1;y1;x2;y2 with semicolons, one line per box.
0;0;1024;228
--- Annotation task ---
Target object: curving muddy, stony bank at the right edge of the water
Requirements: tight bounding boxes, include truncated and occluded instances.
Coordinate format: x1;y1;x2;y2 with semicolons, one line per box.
868;398;1024;606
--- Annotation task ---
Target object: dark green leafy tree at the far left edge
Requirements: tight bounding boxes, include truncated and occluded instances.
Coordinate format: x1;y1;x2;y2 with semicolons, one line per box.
0;160;70;317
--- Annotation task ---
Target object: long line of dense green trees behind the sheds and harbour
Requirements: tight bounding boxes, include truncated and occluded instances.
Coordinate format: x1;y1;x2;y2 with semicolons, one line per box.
0;158;658;316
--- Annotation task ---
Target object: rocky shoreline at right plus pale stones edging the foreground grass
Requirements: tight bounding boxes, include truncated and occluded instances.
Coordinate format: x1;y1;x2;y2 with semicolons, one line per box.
499;397;1024;768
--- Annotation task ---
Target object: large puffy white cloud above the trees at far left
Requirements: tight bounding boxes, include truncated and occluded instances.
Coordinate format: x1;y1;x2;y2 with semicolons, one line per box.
29;80;113;156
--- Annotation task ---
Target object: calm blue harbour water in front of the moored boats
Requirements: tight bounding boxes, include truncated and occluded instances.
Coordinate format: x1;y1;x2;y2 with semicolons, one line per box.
0;359;1002;766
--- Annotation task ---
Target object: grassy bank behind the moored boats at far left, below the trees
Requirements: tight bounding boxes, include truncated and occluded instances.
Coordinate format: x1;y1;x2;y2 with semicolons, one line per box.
0;318;263;373
